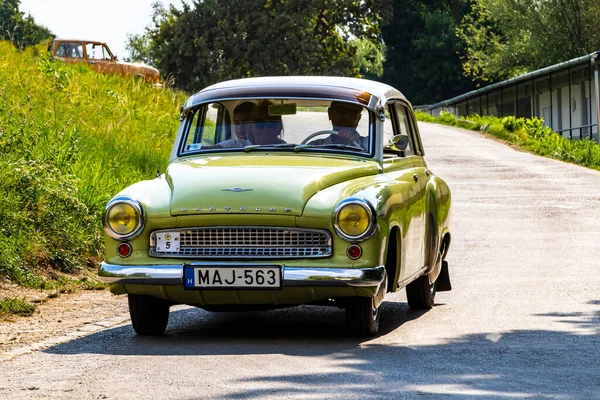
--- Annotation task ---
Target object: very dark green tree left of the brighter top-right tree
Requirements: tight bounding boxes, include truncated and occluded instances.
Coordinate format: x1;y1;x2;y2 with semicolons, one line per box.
381;0;474;104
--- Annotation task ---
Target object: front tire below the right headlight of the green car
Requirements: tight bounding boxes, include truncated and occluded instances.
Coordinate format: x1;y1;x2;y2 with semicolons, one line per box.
346;297;381;337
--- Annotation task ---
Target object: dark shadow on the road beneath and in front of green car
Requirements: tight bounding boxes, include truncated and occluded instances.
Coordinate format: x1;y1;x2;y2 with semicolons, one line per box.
46;301;600;399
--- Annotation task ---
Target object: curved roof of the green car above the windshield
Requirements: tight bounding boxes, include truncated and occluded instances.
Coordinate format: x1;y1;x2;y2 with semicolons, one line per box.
184;76;407;110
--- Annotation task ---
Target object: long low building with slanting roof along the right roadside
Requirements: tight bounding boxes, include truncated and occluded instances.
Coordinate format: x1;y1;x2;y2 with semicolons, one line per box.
426;51;600;142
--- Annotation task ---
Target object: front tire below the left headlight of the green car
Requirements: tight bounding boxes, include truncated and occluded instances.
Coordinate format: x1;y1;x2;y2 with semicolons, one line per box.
127;294;170;336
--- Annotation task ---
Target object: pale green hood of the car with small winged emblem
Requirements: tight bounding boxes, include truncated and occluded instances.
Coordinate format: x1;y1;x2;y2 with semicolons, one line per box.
166;154;380;216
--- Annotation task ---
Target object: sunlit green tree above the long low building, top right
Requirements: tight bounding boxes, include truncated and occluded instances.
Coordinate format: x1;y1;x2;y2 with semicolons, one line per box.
457;0;600;84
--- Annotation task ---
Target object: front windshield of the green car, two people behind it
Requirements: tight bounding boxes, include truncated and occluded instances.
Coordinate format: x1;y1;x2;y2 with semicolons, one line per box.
179;99;373;155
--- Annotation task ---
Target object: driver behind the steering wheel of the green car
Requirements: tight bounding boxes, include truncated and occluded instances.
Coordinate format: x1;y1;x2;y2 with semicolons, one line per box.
311;101;369;151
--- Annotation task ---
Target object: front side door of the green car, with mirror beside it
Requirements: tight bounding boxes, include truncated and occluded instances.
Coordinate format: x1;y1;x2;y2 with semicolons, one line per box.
384;101;428;283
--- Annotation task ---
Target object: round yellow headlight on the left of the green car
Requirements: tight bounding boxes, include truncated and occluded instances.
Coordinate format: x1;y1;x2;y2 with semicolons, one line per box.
104;197;144;239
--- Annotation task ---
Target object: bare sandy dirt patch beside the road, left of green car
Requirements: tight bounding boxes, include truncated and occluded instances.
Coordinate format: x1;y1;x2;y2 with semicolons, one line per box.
0;283;128;354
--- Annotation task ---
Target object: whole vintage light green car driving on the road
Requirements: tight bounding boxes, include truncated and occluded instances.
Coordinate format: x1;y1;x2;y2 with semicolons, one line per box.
99;77;451;336
